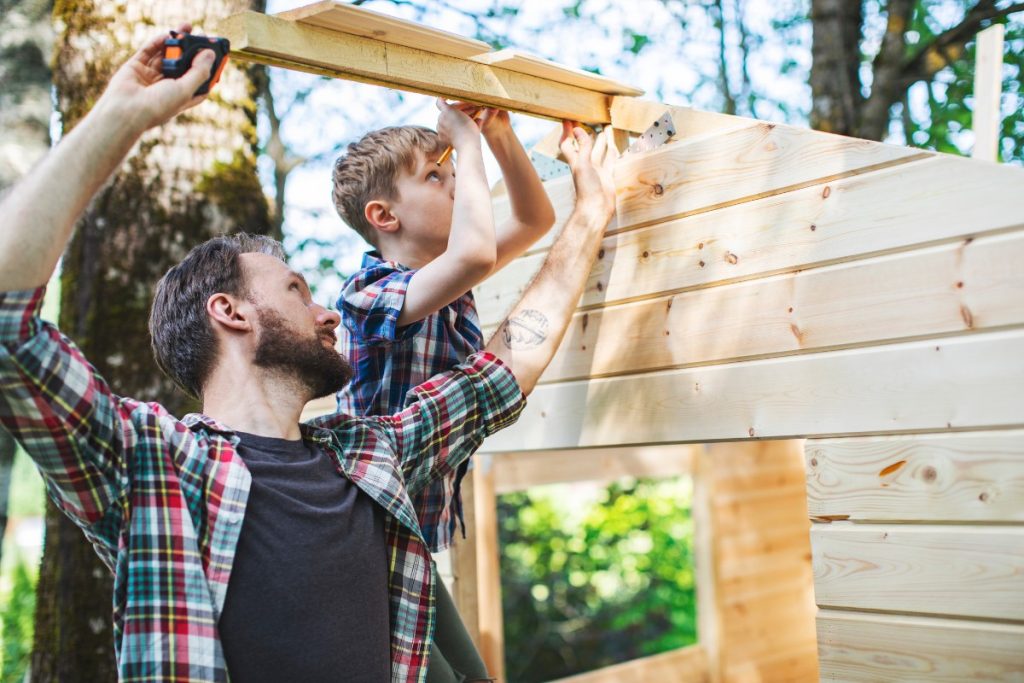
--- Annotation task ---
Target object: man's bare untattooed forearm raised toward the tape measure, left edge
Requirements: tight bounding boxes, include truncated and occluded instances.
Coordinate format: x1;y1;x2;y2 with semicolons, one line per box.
0;99;141;292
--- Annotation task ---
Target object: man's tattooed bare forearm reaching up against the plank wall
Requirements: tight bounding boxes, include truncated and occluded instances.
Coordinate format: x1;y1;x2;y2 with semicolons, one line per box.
485;196;611;394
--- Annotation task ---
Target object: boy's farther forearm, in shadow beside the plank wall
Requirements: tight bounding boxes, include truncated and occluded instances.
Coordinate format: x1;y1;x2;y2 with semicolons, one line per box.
486;128;555;232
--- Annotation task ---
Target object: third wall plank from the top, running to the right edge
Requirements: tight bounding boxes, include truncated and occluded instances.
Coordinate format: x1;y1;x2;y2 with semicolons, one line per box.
488;230;1024;382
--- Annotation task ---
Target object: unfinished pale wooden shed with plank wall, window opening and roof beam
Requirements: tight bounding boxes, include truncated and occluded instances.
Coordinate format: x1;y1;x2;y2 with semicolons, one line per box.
232;2;1024;683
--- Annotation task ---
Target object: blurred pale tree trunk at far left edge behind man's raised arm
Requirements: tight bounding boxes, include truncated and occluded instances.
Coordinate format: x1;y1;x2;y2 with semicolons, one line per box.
0;0;53;558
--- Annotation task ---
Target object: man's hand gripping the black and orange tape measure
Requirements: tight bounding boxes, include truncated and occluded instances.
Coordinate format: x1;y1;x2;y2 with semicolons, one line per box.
97;24;215;132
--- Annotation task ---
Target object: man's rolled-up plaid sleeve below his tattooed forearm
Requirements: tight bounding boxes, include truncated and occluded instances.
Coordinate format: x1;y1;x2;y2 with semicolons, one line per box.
374;351;526;495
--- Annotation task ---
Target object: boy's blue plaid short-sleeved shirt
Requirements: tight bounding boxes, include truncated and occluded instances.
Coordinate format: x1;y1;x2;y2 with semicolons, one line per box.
338;252;483;552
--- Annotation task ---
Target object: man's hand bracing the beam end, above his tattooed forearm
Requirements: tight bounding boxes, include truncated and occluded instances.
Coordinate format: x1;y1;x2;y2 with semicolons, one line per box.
559;121;618;216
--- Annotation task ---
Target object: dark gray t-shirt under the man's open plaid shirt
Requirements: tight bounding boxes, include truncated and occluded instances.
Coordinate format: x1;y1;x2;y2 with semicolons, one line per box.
218;433;391;683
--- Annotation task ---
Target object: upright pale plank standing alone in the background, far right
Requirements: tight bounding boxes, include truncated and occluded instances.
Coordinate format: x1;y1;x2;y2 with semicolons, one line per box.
971;24;1006;161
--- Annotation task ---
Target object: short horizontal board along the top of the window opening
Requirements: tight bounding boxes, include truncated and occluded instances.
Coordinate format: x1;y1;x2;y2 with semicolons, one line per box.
480;445;695;496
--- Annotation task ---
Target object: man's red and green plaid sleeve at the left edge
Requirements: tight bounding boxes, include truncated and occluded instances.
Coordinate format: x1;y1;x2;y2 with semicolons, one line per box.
0;288;134;528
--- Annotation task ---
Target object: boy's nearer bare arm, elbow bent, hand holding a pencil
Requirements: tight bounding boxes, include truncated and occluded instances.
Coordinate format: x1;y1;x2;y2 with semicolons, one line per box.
398;99;496;326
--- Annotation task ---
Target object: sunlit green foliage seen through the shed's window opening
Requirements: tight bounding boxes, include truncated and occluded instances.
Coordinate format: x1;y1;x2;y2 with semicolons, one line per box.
498;480;696;682
